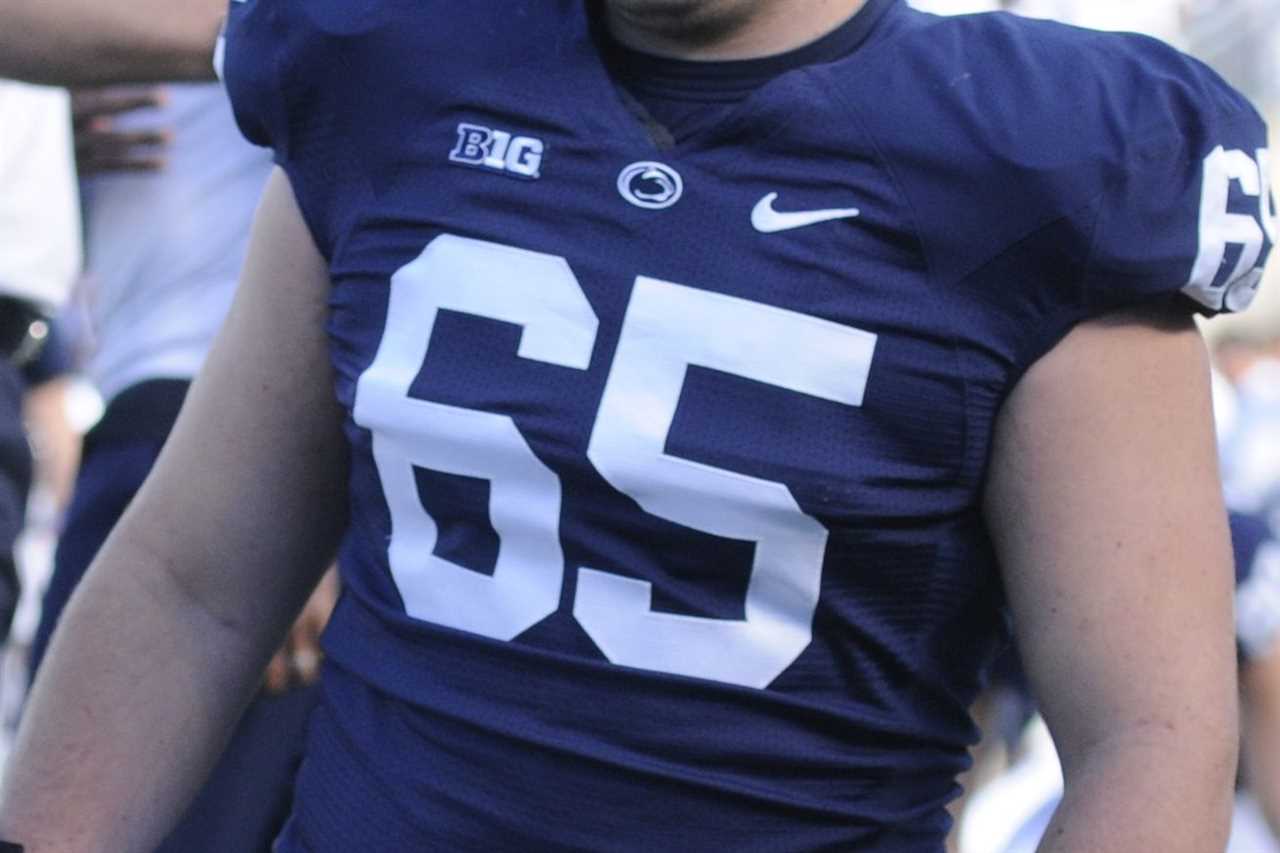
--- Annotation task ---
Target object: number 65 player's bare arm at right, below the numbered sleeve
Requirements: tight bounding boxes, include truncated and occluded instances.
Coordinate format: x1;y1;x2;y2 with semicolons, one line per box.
987;302;1236;853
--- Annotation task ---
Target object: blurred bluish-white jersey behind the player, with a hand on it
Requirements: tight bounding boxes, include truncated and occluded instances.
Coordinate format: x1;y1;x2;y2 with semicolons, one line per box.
83;83;271;401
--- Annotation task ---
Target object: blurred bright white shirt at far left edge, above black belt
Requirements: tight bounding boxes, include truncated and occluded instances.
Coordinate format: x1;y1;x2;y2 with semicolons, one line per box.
0;81;81;307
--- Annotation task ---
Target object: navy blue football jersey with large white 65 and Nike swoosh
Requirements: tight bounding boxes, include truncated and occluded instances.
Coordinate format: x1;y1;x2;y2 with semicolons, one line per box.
225;0;1275;853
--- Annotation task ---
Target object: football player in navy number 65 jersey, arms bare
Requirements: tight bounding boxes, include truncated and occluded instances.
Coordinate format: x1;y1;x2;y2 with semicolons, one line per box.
0;0;1275;853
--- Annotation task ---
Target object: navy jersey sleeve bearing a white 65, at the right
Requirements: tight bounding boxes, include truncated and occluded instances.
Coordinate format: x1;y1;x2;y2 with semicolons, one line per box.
1085;36;1276;314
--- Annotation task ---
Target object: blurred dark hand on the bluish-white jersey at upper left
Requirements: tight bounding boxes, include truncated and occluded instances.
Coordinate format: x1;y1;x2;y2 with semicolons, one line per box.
72;86;172;177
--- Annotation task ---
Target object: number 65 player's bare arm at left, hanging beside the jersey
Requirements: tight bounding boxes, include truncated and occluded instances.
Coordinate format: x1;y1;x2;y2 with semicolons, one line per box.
0;167;346;853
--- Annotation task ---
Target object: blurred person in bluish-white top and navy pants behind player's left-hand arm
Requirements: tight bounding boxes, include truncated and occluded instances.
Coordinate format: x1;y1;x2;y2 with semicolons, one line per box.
24;83;335;853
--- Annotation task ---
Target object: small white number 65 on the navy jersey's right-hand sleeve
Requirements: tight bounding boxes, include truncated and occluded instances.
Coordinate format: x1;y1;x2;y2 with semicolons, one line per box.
1183;145;1276;311
